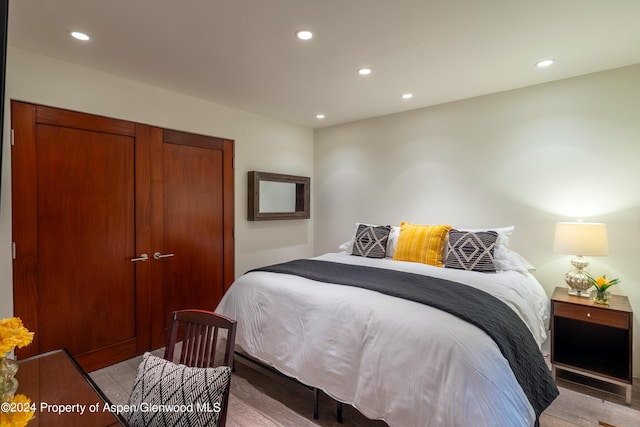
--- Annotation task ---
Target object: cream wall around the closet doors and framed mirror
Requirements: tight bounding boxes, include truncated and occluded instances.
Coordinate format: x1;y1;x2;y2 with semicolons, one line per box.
0;48;314;318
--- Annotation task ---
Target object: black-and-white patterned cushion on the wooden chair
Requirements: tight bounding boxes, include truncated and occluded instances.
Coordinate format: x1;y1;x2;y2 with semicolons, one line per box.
123;352;231;427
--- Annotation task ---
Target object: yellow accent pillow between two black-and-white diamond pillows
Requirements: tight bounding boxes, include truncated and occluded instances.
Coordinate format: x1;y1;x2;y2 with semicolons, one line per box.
393;221;451;267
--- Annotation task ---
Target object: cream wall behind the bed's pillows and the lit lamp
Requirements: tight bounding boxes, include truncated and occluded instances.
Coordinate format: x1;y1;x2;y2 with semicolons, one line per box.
313;65;640;375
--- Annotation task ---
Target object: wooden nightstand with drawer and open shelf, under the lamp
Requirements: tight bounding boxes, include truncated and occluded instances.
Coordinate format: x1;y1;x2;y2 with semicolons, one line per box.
551;288;633;405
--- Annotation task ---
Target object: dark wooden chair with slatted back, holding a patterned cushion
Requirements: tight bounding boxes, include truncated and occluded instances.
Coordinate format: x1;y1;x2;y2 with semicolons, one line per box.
164;310;237;427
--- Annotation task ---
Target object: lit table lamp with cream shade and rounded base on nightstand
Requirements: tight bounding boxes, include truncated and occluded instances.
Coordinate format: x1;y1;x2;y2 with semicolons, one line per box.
553;221;609;297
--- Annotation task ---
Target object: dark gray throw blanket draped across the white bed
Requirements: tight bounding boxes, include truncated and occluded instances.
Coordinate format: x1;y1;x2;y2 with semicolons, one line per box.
251;259;559;424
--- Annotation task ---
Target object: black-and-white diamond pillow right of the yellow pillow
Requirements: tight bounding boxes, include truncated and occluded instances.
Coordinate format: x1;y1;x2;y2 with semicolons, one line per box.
445;230;498;272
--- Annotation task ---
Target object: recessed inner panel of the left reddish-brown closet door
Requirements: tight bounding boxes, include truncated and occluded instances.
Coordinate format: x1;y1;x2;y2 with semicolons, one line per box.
36;125;135;354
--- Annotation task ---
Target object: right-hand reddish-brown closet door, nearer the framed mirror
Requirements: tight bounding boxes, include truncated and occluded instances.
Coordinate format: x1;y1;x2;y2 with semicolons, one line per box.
151;130;234;347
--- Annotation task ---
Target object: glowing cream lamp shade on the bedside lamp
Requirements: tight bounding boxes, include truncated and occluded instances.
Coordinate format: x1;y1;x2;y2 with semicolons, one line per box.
553;222;609;256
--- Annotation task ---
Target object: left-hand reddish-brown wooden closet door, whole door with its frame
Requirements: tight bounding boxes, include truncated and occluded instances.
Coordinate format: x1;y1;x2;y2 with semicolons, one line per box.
12;102;149;369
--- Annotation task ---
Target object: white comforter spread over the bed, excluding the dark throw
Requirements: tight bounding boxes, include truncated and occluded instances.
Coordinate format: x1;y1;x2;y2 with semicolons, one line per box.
216;253;549;427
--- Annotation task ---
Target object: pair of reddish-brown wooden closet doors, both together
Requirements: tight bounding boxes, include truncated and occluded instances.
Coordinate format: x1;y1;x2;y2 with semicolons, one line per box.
11;101;234;370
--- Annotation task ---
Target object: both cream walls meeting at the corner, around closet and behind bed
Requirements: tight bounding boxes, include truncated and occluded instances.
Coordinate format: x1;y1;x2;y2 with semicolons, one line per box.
6;48;640;375
